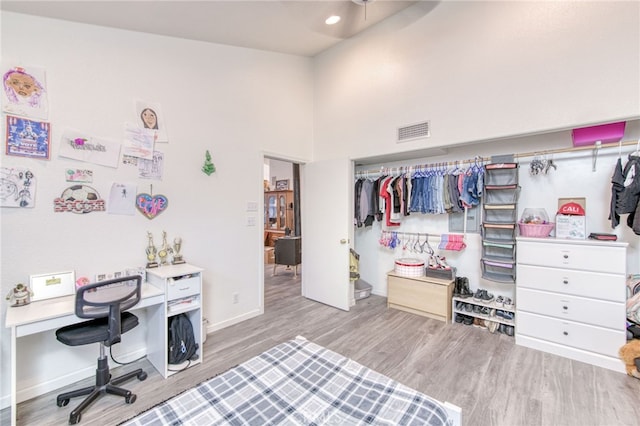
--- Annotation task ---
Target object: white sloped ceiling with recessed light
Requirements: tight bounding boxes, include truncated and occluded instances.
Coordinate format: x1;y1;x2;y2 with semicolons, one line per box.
0;0;437;56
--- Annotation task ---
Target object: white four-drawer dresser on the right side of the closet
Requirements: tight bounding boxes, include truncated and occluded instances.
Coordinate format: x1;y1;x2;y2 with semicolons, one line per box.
516;237;627;373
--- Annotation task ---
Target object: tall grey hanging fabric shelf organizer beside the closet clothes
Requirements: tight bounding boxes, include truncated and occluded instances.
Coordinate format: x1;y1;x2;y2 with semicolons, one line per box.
480;163;520;283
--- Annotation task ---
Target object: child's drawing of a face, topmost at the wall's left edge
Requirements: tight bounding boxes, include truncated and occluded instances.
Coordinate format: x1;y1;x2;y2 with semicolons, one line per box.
2;66;49;119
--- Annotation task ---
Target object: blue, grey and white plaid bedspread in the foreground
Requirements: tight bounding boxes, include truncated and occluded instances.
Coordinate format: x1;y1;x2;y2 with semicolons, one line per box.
123;337;452;426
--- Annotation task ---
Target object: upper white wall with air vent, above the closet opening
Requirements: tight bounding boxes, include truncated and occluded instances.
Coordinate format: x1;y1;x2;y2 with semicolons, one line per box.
314;1;640;159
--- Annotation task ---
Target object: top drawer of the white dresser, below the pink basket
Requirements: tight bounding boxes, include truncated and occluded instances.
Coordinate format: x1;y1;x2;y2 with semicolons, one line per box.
517;240;627;275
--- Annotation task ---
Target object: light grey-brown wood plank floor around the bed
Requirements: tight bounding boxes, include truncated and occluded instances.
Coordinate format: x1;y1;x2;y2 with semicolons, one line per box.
1;266;640;426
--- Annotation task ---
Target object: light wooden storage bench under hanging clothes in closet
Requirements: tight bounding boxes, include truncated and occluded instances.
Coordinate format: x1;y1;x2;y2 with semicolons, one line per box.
387;271;453;323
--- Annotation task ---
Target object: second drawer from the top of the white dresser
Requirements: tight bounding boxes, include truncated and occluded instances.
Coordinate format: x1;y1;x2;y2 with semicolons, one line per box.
516;264;627;302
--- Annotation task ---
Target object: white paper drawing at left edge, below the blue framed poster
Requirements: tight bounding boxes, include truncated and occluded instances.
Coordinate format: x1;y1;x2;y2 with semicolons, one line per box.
0;167;36;208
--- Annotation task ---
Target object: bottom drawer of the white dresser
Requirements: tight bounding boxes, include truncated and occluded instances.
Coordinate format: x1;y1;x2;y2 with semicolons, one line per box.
516;312;626;358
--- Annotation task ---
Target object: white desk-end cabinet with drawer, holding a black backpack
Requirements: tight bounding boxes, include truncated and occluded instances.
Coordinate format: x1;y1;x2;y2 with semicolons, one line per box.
147;263;203;378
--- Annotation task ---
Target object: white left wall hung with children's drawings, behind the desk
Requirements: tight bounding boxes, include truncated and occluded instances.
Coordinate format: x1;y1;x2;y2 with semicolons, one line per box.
0;13;313;401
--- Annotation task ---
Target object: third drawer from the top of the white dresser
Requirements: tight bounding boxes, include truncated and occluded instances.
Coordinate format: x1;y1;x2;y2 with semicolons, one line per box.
516;287;626;330
